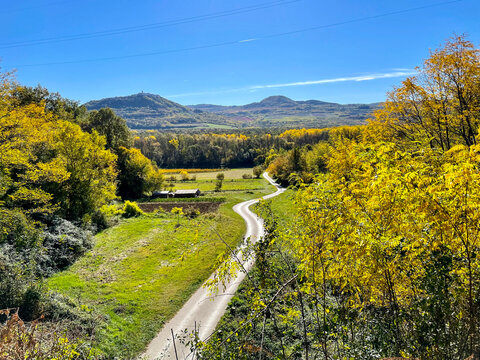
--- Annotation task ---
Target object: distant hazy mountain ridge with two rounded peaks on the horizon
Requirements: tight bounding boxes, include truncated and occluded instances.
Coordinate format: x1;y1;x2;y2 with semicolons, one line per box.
85;92;381;129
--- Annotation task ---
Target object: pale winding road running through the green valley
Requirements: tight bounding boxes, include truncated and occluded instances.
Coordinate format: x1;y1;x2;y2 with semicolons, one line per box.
142;172;285;360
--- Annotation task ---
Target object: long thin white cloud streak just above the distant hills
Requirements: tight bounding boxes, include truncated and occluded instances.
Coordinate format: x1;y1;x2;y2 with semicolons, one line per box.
167;69;415;98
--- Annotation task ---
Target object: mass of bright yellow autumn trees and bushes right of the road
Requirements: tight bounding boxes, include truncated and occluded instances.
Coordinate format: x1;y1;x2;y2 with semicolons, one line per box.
199;37;480;360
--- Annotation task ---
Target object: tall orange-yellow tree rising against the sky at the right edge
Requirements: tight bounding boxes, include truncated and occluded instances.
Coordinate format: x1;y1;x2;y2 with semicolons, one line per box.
373;36;480;151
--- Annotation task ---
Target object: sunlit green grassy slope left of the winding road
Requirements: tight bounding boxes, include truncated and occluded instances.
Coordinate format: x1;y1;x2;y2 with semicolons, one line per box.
49;172;273;358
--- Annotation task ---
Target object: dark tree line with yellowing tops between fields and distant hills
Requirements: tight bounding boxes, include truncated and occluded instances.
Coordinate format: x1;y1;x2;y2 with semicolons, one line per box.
134;129;329;168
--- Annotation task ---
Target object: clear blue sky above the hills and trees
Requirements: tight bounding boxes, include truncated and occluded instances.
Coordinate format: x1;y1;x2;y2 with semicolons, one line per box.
0;0;480;105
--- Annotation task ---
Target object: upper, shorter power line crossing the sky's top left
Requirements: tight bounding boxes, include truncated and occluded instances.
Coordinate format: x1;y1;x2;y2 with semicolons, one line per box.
0;0;302;49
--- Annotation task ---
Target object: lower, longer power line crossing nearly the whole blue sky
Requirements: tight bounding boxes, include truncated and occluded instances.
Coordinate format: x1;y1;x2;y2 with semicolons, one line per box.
7;0;464;68
